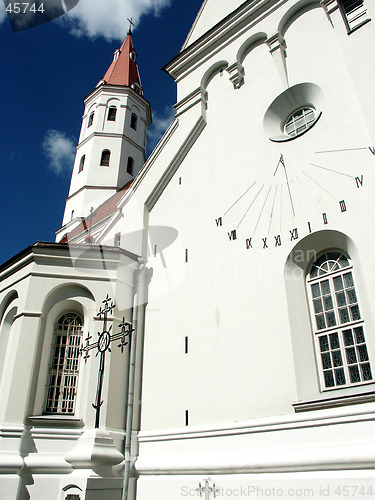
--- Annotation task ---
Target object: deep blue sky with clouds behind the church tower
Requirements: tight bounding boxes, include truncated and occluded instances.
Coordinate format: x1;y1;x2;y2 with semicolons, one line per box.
0;0;202;263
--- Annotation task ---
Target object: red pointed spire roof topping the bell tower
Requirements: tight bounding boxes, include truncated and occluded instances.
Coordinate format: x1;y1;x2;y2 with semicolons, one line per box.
98;34;143;95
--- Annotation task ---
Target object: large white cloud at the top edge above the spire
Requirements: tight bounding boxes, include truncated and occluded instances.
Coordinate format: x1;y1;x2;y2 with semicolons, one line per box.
61;0;170;41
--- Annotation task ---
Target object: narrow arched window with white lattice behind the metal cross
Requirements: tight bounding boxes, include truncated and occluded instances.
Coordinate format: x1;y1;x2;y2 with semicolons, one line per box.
45;313;83;415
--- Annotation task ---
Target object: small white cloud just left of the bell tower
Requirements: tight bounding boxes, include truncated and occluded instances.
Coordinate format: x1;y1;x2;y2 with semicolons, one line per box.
42;130;75;174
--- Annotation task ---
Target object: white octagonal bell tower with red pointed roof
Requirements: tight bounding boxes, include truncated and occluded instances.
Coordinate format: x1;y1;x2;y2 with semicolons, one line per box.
63;30;151;228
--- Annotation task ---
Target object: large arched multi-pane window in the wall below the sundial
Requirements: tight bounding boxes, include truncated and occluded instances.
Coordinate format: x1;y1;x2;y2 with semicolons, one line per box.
307;252;372;389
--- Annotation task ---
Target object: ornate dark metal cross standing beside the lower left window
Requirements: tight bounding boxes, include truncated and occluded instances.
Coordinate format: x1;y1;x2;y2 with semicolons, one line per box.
80;294;134;429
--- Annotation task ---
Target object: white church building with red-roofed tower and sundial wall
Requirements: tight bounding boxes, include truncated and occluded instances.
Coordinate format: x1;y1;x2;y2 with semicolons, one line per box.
0;0;375;500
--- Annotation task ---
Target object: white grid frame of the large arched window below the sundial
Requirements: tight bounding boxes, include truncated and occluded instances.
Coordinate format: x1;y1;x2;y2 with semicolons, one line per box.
305;254;375;392
